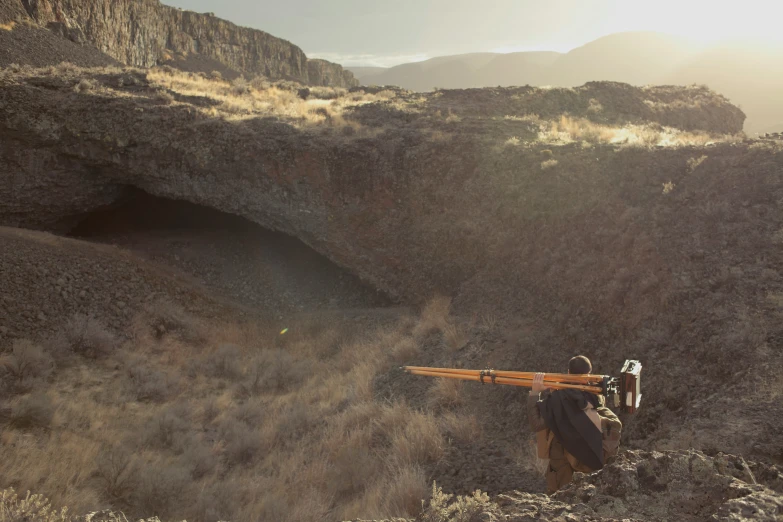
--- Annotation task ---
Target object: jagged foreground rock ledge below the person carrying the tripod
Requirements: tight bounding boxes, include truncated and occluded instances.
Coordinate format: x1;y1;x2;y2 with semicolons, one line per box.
408;450;783;522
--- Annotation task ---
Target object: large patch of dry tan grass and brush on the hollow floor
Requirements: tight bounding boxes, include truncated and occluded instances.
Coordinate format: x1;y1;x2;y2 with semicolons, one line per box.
0;299;475;522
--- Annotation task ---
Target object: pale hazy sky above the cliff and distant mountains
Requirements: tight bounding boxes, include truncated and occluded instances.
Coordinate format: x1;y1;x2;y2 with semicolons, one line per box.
163;0;783;66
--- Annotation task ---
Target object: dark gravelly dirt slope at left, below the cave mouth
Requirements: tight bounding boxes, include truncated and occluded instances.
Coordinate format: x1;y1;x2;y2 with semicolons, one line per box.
0;227;239;348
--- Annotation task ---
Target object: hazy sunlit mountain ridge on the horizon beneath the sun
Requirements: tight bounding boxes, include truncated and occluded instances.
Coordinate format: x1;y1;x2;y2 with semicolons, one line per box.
348;32;783;133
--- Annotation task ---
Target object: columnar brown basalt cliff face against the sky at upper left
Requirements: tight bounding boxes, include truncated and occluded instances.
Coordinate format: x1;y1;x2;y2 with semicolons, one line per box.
9;0;358;87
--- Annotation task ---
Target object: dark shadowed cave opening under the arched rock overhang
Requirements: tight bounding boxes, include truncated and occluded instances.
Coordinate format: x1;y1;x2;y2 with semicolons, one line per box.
69;188;391;312
